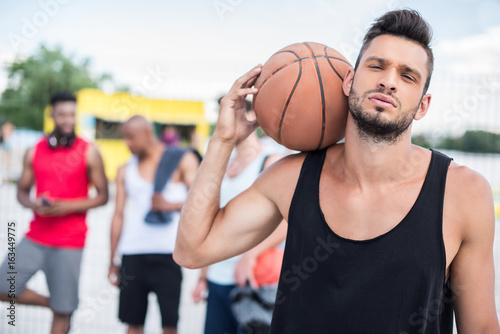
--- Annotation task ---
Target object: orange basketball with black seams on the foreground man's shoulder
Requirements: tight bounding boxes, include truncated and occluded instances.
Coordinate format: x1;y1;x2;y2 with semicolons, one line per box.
253;42;351;151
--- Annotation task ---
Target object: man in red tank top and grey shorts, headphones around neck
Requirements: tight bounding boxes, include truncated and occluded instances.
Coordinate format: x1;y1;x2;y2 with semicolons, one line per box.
0;92;108;333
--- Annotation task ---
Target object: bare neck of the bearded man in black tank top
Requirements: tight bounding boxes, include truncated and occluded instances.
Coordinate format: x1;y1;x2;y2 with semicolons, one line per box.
341;117;425;188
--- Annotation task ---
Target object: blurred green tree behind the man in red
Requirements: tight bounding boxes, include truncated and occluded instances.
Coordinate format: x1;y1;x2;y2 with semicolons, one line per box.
0;44;112;130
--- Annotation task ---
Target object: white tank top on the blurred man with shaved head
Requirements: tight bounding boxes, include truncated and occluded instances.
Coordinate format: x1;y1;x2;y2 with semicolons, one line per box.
118;156;187;255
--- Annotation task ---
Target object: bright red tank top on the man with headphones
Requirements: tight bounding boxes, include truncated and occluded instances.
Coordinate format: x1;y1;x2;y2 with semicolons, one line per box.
26;137;90;249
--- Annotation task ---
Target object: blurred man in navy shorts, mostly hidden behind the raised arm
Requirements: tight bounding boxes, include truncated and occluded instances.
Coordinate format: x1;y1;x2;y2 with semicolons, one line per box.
193;101;287;334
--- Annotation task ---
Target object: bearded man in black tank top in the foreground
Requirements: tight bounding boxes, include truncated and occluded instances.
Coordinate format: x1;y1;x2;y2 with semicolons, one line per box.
174;10;500;334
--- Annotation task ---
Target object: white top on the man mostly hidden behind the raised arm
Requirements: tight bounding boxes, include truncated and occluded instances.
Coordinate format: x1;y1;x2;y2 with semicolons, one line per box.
207;150;267;285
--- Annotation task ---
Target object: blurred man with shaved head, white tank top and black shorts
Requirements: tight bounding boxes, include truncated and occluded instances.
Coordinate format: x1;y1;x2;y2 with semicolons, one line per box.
108;116;199;334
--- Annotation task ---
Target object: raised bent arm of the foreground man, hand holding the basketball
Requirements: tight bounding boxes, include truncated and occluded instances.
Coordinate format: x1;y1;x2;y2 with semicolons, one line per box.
174;65;282;268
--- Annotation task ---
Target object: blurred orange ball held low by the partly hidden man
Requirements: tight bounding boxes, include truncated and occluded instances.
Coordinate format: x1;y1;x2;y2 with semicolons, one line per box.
253;248;284;286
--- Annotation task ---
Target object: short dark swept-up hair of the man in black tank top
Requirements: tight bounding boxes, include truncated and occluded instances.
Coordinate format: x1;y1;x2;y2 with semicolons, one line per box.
354;9;434;94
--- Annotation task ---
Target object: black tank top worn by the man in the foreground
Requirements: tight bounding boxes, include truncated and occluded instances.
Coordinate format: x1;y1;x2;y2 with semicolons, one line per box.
271;149;453;334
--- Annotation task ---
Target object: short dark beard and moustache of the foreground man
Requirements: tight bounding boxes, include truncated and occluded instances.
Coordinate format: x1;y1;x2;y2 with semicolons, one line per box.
348;87;418;144
